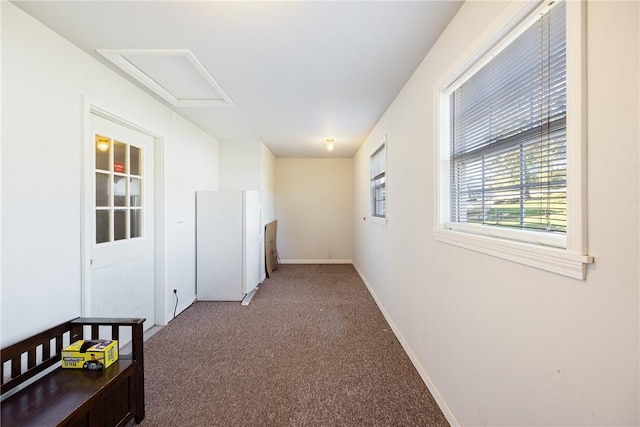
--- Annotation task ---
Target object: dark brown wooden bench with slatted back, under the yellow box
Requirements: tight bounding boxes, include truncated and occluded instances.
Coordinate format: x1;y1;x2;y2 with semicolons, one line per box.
0;317;145;427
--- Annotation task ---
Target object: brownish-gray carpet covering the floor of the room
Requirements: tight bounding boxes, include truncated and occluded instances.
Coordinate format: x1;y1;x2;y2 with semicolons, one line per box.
142;265;448;427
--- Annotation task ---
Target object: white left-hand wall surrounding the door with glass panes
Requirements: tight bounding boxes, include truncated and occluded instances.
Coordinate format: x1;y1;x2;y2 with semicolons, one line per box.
1;2;218;346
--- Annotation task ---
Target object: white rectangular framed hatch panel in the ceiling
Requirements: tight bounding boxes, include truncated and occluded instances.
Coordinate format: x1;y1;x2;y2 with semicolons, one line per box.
96;49;235;107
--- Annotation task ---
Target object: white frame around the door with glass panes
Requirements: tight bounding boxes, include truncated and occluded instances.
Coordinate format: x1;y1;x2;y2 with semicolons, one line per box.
80;97;167;326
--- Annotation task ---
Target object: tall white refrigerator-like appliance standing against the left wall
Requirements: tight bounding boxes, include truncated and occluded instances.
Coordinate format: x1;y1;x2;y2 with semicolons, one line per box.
196;191;262;301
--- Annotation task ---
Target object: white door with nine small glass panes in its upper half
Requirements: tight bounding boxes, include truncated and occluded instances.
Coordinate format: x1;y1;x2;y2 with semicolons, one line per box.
84;114;155;329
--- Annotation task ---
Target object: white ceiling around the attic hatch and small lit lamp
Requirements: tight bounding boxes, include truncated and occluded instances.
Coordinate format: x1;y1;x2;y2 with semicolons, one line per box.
13;0;462;157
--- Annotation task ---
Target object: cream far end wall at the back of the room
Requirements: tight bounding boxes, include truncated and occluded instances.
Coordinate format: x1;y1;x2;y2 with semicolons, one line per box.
275;158;353;263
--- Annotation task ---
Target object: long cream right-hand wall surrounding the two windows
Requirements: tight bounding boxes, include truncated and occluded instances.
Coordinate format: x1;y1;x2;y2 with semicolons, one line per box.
353;1;640;426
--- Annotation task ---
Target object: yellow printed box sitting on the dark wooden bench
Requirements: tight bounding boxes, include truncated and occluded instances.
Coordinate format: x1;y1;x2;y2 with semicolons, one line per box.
62;340;118;371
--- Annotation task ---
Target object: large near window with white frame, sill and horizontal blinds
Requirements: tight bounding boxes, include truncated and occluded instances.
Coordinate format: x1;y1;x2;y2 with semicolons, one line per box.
435;0;593;278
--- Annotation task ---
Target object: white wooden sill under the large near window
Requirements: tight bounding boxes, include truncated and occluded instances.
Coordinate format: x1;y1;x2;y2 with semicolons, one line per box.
433;230;594;280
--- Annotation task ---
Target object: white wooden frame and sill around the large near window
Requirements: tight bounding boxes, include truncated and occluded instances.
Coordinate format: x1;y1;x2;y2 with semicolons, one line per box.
433;0;593;280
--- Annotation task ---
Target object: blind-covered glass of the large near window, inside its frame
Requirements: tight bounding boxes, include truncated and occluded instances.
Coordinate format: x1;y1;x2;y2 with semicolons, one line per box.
448;2;567;234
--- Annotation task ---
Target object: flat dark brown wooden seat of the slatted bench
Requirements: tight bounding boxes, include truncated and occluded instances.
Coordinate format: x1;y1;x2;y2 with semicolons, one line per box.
1;359;135;426
